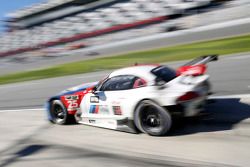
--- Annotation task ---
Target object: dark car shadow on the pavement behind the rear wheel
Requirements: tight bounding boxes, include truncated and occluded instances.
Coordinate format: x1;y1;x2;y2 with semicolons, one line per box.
168;98;250;136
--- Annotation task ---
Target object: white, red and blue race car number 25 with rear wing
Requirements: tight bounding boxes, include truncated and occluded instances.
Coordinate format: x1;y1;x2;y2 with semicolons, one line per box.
46;55;218;136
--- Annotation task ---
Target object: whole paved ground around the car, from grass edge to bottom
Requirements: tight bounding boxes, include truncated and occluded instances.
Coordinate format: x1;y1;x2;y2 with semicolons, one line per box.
0;53;250;167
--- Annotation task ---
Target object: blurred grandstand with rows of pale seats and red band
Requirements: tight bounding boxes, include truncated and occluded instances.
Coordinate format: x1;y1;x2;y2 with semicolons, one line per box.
0;0;244;57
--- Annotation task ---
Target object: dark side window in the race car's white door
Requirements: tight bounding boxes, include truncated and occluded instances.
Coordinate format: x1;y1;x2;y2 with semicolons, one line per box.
100;75;136;91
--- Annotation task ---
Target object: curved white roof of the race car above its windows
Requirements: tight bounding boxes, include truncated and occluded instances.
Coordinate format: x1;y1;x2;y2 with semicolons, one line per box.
109;65;159;81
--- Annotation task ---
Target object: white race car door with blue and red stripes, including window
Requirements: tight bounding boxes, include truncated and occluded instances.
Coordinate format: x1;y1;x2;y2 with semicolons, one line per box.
82;75;137;118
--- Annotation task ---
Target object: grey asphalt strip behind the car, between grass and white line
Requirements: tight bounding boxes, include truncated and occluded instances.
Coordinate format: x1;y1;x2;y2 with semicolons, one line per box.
0;53;250;110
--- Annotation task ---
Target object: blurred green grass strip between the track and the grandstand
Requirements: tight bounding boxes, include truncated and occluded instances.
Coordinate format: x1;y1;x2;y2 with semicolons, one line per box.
0;34;250;84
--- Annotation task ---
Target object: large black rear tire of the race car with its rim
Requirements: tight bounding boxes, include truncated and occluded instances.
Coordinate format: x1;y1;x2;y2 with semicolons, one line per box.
134;100;172;136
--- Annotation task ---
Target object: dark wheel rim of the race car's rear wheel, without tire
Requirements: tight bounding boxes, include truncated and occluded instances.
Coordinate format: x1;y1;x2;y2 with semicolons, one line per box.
141;106;161;131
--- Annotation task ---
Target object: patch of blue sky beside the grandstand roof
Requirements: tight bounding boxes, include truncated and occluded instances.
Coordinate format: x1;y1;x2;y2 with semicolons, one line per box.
0;0;44;32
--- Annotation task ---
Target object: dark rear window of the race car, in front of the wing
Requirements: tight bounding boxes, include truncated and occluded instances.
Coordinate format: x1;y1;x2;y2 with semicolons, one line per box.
151;66;176;82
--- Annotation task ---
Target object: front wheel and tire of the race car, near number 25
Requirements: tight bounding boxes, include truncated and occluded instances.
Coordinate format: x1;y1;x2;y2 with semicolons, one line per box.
50;100;75;125
